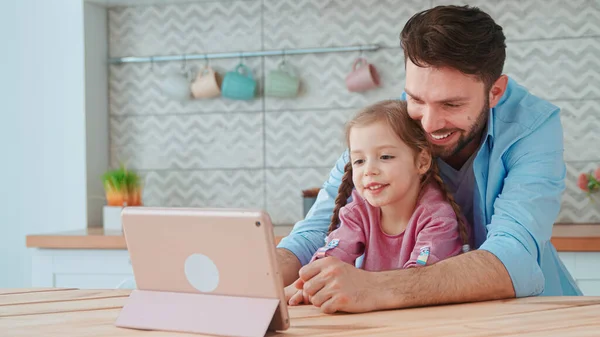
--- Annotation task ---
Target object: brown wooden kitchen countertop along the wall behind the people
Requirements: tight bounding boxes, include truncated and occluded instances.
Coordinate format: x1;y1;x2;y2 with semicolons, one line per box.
26;223;600;252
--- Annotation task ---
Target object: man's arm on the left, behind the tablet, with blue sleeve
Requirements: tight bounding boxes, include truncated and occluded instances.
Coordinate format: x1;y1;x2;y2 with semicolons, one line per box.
277;151;349;286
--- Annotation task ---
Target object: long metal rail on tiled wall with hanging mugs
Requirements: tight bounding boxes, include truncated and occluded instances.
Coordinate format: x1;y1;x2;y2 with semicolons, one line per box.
108;44;379;63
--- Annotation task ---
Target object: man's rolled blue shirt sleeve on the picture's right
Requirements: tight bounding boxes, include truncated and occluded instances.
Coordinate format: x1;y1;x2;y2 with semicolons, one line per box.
480;109;566;297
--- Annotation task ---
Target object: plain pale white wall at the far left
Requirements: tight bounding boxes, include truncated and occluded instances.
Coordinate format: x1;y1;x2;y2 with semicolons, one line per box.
0;0;87;287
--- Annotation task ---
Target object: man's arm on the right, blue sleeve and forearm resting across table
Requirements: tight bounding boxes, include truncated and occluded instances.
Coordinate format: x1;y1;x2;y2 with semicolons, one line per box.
300;111;565;312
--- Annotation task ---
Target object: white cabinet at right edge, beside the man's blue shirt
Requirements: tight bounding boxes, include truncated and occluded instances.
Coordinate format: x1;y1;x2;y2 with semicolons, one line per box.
558;252;600;296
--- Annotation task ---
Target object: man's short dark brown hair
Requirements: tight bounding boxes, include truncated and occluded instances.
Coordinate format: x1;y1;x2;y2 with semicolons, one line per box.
400;6;506;90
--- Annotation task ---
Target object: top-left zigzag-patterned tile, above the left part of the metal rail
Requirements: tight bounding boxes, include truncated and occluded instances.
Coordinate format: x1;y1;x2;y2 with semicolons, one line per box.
108;1;262;57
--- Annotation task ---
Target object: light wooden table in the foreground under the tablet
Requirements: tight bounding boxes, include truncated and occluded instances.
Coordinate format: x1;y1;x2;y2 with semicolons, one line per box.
0;288;600;337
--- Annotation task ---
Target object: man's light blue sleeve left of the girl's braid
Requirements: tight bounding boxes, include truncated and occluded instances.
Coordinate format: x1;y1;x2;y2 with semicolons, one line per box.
277;150;349;265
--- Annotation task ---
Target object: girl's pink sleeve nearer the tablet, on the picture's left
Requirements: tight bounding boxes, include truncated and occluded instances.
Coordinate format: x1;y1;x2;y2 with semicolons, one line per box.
311;204;366;265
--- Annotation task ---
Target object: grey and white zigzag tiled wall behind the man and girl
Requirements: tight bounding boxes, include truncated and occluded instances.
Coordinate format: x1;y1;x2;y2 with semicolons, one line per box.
109;0;600;224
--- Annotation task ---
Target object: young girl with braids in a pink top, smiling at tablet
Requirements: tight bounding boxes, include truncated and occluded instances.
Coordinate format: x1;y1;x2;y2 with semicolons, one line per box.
288;100;469;305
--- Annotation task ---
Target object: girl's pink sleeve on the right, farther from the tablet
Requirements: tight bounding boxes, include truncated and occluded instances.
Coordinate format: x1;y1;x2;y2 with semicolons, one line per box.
403;205;462;268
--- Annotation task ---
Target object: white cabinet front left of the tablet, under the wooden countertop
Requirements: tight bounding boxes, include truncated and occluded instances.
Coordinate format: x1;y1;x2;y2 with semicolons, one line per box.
32;249;135;289
